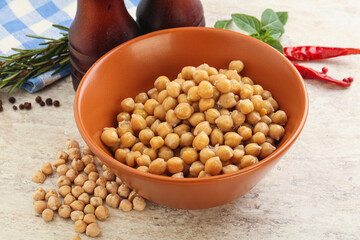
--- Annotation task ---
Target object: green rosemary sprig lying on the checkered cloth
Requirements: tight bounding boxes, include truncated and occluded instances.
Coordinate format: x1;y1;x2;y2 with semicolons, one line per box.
0;24;70;93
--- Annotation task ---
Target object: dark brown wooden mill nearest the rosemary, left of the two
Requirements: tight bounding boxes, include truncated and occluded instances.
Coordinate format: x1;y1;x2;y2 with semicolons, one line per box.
69;0;139;90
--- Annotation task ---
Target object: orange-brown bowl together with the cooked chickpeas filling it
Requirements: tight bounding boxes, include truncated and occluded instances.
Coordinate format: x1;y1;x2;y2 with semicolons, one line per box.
74;27;308;209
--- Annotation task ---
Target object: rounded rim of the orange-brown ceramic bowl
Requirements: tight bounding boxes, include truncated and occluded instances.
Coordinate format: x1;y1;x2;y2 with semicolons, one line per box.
74;27;309;184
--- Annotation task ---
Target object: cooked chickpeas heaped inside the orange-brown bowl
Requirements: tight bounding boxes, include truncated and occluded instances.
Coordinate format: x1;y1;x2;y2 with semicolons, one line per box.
101;60;287;178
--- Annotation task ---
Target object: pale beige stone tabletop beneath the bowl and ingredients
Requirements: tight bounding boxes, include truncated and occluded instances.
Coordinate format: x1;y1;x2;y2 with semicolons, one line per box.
0;0;360;240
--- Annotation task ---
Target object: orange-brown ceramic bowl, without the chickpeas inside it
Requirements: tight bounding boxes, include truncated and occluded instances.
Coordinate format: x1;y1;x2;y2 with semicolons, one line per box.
74;27;308;209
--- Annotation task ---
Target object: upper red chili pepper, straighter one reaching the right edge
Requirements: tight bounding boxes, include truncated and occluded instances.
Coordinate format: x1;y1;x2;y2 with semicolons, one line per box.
284;46;360;61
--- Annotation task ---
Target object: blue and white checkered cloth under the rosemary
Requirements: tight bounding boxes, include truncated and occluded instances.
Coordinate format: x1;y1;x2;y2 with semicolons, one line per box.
0;0;140;93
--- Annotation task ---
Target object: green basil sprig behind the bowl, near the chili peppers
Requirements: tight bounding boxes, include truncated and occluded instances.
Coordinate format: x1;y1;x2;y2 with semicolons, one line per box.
214;8;288;53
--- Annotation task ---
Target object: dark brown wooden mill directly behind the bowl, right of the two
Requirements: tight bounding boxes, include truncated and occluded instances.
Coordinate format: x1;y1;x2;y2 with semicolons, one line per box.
136;0;205;33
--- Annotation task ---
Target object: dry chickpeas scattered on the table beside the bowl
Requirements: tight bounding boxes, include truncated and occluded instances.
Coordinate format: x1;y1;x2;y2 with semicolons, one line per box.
32;139;146;239
